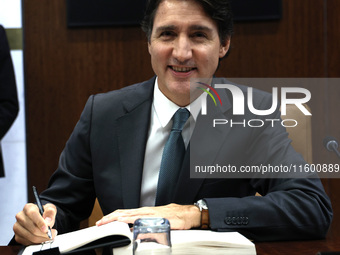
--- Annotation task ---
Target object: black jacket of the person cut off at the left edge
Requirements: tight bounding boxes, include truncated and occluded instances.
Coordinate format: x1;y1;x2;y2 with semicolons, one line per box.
0;25;19;177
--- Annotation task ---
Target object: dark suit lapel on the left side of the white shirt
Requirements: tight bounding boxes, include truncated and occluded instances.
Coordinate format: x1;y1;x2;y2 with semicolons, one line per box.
117;78;154;208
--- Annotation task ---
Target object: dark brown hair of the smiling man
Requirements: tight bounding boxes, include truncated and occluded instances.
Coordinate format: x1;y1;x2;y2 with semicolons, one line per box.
141;0;233;44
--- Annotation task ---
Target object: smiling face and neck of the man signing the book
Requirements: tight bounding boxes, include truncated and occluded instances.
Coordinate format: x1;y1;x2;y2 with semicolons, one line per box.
149;1;231;107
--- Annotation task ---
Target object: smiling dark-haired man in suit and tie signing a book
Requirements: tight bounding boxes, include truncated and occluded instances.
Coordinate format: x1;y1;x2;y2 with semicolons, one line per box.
14;0;332;245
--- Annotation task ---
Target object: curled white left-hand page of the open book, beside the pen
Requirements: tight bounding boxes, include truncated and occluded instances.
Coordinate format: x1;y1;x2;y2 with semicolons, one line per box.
23;221;132;255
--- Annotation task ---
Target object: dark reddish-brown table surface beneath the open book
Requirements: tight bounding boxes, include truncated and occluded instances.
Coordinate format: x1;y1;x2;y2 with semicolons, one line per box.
0;236;340;255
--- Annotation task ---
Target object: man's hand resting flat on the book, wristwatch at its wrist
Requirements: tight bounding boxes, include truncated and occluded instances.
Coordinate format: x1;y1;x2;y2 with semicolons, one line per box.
96;204;201;229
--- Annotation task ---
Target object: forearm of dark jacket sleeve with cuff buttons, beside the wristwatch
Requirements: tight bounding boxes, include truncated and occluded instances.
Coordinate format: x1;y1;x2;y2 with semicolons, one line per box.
206;175;332;241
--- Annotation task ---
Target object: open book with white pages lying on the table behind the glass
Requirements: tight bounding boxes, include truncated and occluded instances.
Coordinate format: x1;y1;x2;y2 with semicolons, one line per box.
23;221;256;255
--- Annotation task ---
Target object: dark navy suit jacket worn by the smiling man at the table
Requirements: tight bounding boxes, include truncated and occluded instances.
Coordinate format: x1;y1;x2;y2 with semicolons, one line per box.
41;75;332;240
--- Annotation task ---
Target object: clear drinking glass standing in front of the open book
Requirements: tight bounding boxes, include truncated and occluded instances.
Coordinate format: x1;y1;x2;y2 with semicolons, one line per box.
133;218;171;255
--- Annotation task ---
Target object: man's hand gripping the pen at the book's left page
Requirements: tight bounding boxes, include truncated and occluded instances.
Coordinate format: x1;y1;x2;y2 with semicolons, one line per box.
13;204;57;245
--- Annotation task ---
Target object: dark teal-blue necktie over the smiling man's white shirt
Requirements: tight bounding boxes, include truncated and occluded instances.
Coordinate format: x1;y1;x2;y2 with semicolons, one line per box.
156;108;190;205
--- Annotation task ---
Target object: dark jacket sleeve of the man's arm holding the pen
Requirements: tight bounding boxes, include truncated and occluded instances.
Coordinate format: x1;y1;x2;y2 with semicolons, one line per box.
41;96;95;233
